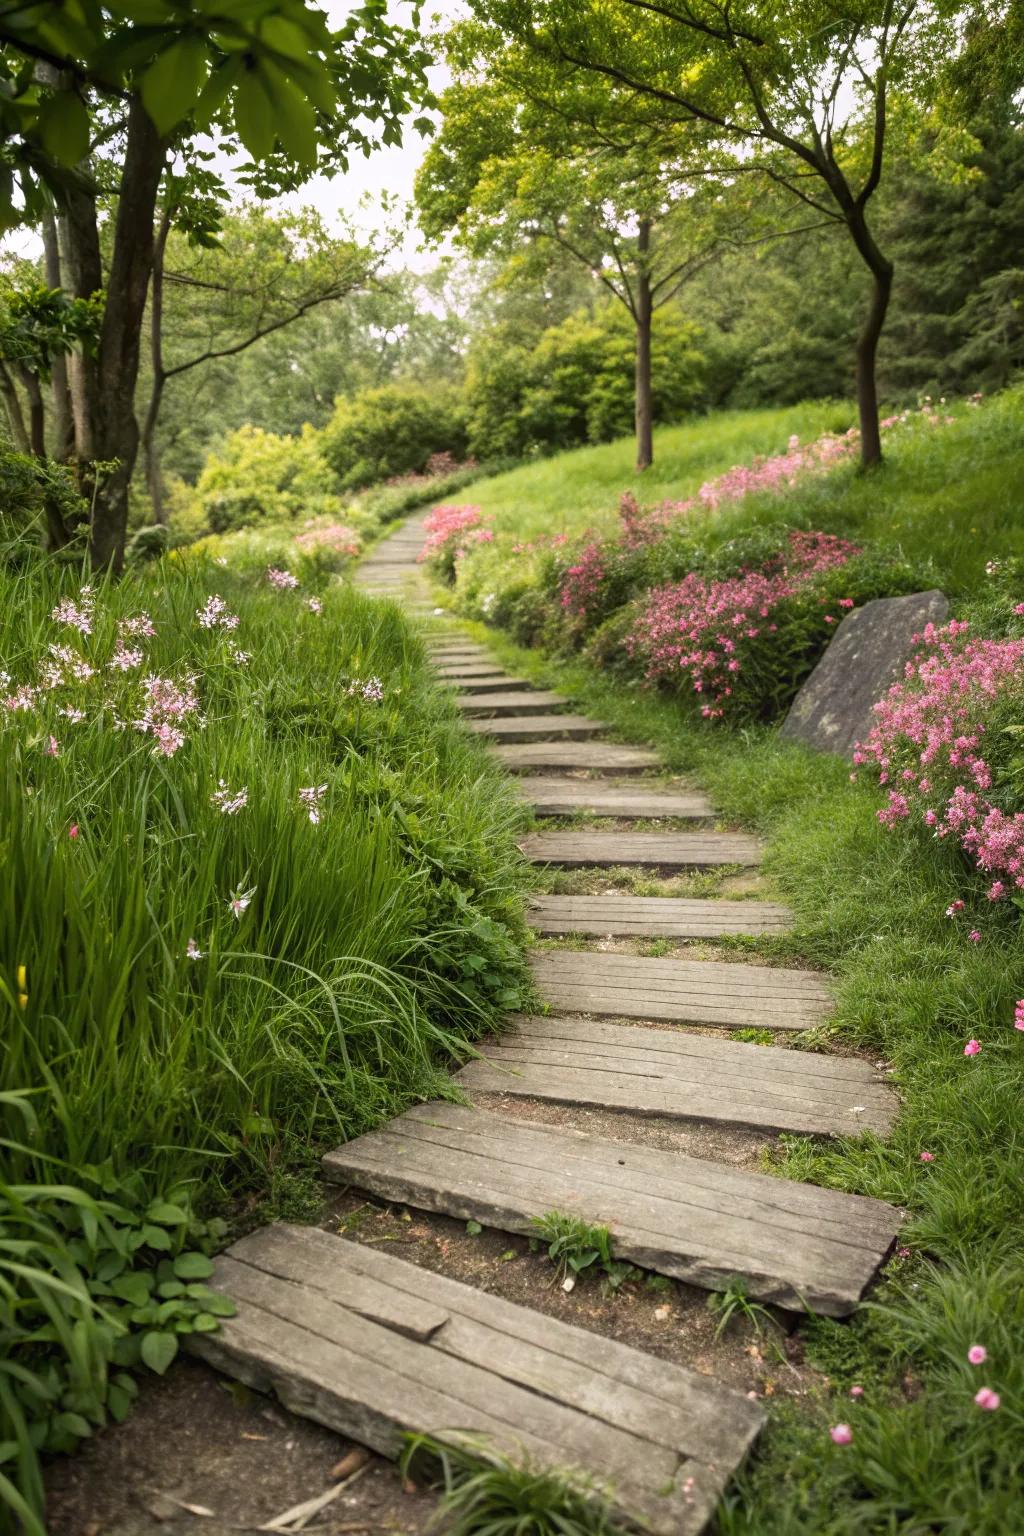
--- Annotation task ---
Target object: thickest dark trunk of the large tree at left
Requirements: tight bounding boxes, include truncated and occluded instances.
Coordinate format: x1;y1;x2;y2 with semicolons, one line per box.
86;97;166;571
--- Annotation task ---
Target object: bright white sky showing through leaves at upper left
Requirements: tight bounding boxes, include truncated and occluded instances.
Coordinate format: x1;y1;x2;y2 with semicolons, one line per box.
0;0;465;270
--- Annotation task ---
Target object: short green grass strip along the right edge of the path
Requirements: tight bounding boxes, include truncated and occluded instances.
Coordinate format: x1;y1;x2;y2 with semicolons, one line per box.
451;577;1024;1536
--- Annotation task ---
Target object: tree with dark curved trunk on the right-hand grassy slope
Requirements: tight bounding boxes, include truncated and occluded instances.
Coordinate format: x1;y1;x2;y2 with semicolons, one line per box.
471;0;958;465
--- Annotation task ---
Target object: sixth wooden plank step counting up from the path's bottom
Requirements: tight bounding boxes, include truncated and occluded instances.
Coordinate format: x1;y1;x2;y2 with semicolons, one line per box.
519;828;761;869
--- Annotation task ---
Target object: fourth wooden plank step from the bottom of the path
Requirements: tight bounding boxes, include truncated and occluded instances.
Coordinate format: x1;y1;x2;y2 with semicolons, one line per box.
530;949;832;1029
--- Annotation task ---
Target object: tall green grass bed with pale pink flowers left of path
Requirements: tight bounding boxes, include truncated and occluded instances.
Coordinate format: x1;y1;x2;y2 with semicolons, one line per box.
0;558;524;1530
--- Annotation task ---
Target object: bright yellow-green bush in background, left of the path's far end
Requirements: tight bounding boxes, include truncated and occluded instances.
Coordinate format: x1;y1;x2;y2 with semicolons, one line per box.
195;425;344;533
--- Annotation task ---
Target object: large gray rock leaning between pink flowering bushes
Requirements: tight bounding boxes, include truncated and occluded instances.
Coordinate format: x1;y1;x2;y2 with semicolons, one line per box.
781;591;949;757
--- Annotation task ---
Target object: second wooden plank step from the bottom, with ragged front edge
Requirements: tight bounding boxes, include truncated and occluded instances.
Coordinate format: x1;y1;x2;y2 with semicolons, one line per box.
322;1103;900;1314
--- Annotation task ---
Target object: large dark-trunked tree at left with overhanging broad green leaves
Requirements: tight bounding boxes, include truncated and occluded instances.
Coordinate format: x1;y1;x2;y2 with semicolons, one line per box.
0;0;430;570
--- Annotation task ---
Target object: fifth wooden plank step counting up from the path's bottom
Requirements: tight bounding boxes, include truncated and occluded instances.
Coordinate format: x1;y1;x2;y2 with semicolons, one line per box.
527;892;792;938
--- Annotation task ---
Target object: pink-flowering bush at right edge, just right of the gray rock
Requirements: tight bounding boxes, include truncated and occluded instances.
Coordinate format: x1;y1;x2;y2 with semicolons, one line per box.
854;619;1024;902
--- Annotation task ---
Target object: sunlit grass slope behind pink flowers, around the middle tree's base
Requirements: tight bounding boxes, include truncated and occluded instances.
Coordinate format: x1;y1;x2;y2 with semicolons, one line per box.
457;401;854;541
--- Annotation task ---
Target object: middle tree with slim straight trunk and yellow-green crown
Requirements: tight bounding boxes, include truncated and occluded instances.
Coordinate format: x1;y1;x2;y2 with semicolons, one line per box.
416;43;735;470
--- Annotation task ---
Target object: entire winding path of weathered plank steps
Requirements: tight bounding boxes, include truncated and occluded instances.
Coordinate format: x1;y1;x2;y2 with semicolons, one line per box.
193;516;901;1536
